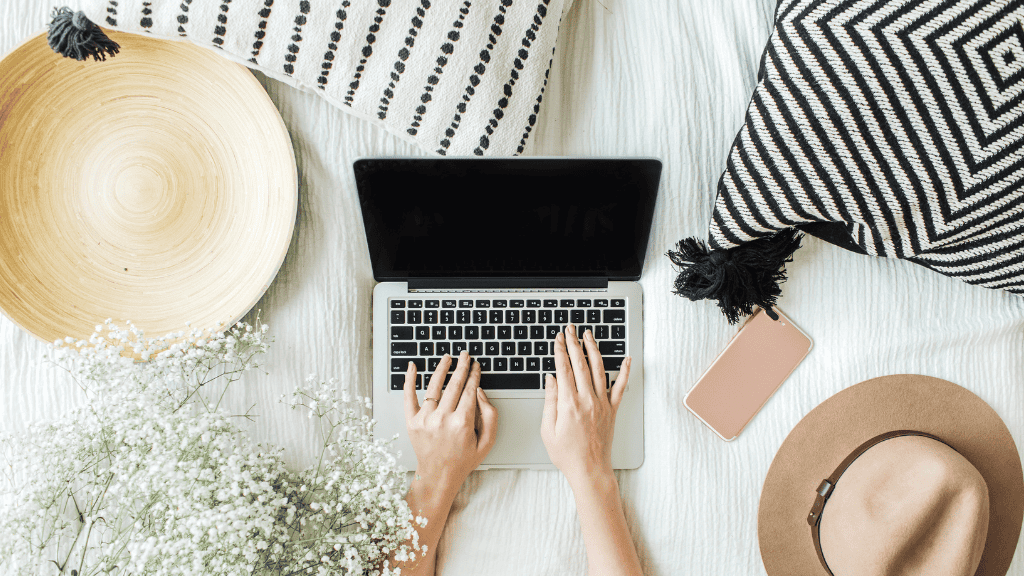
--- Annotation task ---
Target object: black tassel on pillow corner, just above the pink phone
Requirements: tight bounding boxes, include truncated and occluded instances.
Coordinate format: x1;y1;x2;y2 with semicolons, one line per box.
667;229;803;324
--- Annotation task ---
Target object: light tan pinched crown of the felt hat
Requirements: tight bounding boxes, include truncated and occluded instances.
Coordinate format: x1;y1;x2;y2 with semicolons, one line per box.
819;436;989;576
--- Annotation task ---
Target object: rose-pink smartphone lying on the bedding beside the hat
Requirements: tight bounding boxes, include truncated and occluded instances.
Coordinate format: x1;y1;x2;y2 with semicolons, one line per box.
683;307;814;442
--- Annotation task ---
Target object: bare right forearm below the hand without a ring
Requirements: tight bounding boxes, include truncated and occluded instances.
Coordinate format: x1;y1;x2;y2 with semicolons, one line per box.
572;474;642;576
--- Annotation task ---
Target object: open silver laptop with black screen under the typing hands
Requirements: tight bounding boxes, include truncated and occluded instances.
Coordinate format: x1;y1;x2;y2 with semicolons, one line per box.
354;158;662;470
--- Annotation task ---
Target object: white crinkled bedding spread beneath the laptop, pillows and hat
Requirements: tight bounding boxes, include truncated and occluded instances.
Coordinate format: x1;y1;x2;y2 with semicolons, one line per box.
0;0;1024;576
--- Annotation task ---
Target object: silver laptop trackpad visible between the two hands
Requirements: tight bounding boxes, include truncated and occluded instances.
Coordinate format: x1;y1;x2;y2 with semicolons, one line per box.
482;398;551;467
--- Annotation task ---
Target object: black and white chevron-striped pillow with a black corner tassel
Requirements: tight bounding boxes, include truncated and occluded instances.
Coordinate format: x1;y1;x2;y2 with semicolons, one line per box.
670;0;1024;316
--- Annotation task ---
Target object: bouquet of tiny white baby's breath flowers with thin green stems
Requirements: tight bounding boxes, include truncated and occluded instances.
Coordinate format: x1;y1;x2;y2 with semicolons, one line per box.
0;321;426;576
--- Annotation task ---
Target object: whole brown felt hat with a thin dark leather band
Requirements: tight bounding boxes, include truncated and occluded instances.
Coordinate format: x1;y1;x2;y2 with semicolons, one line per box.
758;374;1024;576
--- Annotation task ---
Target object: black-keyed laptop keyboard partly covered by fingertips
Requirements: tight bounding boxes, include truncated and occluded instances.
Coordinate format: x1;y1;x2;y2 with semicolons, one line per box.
388;297;627;390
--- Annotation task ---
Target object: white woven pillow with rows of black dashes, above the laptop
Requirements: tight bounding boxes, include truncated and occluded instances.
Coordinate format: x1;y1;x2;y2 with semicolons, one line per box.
83;0;571;156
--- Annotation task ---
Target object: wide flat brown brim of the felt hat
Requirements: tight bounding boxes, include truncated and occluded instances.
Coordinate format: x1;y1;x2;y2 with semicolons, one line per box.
758;374;1024;576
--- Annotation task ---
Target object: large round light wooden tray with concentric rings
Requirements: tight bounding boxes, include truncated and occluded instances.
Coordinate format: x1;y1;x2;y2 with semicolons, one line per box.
0;30;298;342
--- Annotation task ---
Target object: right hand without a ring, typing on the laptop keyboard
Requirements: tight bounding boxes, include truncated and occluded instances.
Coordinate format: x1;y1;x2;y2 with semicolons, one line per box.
541;324;631;483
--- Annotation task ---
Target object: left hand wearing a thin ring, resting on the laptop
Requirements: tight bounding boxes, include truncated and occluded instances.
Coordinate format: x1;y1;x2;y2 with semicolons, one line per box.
406;351;498;496
